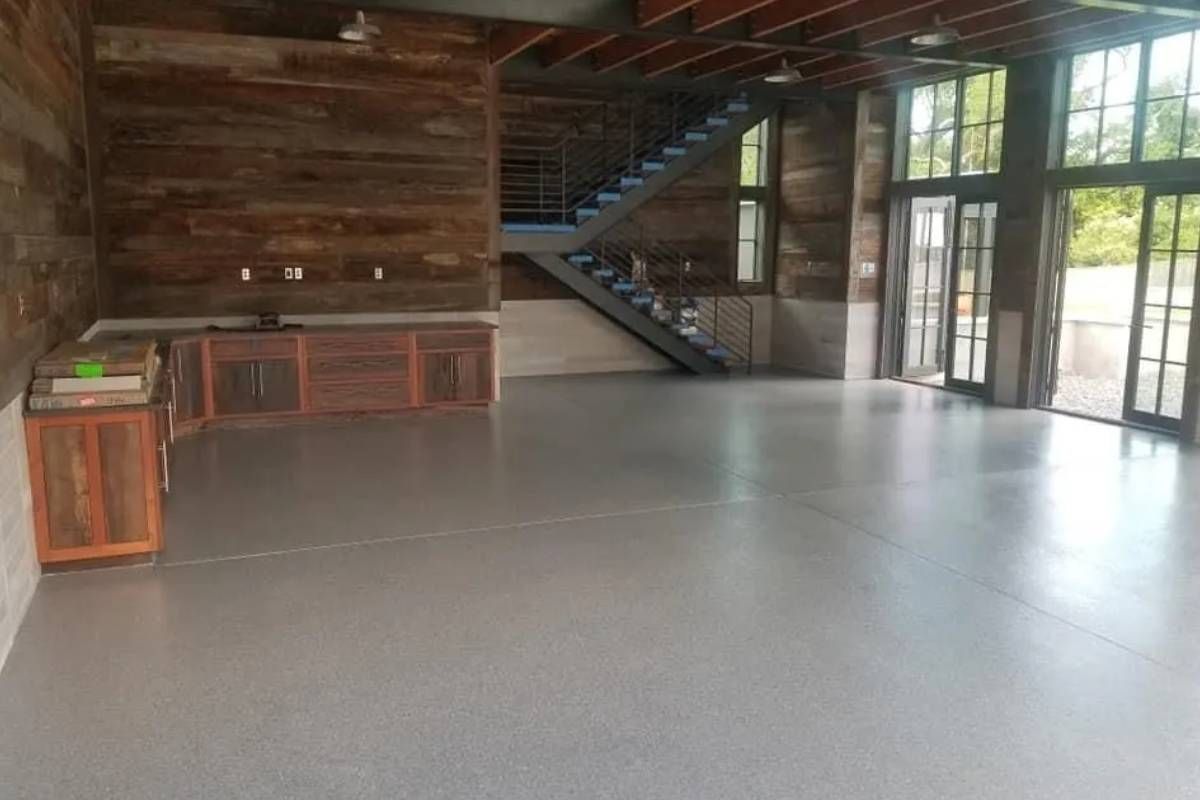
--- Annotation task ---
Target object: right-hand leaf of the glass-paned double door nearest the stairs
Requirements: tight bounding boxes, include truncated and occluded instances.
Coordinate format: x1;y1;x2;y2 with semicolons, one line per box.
946;203;997;391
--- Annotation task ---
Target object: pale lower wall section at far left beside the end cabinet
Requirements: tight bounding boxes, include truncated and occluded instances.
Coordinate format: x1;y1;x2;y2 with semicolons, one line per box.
0;395;41;667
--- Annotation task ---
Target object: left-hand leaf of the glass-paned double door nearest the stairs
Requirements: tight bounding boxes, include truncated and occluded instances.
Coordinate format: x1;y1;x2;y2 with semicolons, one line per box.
900;197;954;378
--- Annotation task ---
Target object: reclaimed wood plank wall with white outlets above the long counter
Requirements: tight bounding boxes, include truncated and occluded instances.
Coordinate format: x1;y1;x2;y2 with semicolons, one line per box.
95;0;499;317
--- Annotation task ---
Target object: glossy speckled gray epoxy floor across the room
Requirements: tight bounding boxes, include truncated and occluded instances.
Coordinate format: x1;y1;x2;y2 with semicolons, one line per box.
0;375;1200;800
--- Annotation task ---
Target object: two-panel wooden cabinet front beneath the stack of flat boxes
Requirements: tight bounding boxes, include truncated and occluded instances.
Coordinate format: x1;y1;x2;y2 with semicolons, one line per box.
25;407;167;564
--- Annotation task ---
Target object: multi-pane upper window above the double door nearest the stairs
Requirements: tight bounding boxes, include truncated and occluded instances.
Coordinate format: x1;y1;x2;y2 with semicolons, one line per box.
905;70;1007;180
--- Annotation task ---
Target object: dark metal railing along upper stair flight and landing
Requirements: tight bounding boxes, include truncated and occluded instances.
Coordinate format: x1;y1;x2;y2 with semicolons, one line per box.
500;92;734;224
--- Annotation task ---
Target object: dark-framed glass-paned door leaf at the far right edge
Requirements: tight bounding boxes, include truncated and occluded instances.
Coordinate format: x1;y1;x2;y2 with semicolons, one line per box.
1124;190;1200;431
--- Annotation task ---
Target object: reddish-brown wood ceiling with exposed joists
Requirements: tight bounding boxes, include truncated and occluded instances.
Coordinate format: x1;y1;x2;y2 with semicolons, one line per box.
482;0;1198;89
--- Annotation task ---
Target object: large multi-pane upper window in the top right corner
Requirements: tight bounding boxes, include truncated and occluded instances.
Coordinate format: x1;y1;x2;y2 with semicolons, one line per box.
1062;31;1200;167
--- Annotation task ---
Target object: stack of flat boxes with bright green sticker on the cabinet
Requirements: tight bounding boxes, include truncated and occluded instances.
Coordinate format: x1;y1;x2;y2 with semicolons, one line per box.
29;341;160;411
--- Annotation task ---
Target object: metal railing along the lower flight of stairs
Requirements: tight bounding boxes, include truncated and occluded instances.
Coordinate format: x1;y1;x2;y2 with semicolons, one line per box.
578;221;754;372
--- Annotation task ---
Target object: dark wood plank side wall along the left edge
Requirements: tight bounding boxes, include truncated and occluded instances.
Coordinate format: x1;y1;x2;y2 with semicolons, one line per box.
0;0;96;407
